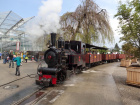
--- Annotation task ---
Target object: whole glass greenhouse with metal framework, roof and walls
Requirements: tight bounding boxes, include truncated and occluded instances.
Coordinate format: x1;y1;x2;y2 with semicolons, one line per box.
0;11;34;52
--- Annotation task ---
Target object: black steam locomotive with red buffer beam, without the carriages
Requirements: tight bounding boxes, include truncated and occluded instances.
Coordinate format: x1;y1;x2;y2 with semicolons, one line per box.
36;33;85;86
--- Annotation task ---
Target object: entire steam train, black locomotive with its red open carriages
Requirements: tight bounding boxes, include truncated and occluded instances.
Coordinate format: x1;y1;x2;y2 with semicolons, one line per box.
36;33;125;86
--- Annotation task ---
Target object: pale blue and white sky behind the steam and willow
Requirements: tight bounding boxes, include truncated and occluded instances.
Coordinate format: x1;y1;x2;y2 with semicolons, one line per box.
0;0;125;47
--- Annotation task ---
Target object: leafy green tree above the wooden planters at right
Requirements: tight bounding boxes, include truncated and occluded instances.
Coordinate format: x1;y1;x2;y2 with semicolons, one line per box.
115;0;140;57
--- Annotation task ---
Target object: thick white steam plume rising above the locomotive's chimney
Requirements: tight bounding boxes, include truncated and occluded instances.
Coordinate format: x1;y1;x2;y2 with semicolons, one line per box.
26;0;63;37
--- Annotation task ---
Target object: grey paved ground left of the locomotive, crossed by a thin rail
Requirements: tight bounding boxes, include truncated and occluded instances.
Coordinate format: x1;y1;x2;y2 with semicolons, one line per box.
0;60;38;105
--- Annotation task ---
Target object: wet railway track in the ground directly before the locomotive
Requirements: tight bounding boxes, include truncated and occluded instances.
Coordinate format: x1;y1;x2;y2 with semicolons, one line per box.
11;85;64;105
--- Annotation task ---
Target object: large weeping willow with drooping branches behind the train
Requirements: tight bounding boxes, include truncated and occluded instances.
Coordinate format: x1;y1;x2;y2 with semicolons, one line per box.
60;0;114;44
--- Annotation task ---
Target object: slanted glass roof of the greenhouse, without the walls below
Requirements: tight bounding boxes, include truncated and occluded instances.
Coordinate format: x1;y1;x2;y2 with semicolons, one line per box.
0;11;34;51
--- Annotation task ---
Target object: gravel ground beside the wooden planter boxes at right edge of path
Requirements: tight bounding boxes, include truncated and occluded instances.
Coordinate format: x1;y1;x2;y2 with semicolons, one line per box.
113;65;140;105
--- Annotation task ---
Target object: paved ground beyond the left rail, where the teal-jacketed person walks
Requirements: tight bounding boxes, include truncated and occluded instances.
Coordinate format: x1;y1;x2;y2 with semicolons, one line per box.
0;60;38;85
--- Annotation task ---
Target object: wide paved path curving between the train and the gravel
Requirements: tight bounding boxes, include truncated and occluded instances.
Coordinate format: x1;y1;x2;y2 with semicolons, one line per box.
37;63;123;105
